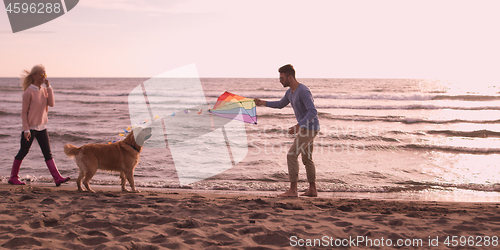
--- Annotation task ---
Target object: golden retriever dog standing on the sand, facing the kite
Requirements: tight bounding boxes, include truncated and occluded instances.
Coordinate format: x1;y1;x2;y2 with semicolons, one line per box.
64;127;151;193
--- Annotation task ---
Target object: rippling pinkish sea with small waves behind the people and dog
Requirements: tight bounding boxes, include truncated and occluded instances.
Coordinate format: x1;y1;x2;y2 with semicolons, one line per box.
0;78;500;199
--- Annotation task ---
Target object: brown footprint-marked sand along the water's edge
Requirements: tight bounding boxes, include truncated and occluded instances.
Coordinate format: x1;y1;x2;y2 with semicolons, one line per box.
0;182;500;249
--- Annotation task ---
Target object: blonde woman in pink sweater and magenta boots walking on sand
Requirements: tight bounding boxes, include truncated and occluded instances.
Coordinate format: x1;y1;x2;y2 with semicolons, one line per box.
9;65;70;186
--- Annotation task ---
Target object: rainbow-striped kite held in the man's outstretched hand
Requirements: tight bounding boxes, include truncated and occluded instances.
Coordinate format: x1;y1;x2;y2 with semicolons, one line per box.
208;91;257;124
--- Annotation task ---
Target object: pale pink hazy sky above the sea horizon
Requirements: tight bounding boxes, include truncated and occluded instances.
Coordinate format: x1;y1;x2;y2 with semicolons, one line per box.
0;0;500;82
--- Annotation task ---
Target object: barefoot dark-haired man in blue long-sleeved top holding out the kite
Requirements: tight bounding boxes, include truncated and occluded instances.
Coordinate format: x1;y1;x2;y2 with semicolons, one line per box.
255;64;319;197
